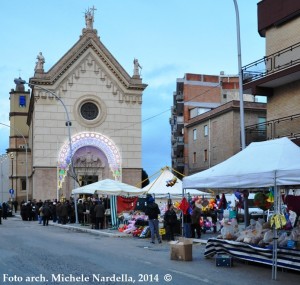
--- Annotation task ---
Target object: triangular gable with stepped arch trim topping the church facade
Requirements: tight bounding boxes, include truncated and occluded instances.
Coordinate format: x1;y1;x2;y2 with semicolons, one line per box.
30;29;147;91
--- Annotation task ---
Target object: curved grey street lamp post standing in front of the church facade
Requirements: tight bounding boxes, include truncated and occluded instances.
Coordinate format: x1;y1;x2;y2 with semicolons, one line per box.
14;78;78;223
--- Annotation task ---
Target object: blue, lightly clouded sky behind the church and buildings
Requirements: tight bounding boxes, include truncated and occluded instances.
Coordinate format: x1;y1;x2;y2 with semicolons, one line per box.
0;0;265;176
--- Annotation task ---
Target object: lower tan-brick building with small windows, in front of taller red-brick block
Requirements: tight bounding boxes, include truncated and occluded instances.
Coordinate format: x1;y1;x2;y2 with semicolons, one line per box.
184;100;266;175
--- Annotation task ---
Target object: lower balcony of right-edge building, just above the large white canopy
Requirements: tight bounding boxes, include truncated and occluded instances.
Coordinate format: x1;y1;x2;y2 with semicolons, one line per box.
245;114;300;145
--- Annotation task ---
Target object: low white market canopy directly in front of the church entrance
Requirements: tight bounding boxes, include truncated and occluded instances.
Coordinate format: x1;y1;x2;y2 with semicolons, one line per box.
72;179;145;197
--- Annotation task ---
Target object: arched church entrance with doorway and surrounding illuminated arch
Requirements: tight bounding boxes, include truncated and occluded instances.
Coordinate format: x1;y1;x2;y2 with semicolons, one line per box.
58;132;122;191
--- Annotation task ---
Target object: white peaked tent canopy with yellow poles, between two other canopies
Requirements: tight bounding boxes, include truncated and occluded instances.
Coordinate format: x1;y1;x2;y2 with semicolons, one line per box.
143;166;208;198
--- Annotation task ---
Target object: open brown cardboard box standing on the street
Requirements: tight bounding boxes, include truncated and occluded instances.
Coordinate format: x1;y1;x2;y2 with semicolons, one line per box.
170;238;193;261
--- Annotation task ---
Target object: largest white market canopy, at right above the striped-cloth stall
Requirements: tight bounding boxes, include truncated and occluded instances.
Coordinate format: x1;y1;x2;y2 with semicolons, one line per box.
183;137;300;189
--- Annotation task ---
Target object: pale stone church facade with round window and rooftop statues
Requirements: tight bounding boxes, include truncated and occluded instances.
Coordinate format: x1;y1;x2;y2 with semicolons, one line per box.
10;9;147;200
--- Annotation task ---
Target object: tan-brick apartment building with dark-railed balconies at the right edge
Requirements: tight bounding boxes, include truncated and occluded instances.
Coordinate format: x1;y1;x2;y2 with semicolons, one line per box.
243;0;300;145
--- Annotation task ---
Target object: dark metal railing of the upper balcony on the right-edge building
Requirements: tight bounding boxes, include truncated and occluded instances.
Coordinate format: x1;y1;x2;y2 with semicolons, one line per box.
242;40;300;84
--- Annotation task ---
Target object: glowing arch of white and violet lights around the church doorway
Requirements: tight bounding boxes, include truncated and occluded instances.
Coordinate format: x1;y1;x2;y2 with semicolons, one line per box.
58;132;122;188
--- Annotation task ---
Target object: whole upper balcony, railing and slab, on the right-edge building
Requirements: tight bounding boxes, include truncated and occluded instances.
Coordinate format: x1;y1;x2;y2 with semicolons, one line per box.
242;43;300;96
